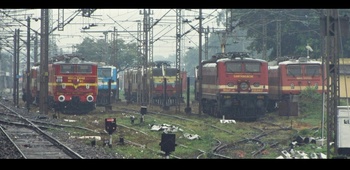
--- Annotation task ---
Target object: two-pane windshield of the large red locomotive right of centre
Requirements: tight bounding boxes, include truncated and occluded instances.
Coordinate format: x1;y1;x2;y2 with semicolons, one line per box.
226;62;260;73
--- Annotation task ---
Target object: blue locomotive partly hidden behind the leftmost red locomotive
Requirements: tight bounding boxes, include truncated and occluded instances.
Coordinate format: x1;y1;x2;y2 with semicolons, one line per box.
96;65;119;106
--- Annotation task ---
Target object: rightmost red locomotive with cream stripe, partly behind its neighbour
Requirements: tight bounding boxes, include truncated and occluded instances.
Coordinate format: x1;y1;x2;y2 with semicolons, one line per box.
268;57;325;115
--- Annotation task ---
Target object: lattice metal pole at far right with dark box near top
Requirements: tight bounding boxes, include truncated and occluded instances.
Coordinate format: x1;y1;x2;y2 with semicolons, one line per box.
321;9;349;158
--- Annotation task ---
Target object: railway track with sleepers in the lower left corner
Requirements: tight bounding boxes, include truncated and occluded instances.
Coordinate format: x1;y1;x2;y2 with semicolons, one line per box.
0;102;83;159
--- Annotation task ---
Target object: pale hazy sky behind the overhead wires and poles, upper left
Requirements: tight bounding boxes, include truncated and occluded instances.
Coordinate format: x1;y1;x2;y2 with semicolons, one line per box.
14;9;221;57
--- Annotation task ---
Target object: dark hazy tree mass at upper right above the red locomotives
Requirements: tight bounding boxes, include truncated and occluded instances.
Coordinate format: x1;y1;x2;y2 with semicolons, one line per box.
219;9;350;60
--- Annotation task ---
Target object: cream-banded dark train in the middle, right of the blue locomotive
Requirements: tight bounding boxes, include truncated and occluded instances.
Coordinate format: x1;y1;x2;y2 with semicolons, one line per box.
123;61;187;107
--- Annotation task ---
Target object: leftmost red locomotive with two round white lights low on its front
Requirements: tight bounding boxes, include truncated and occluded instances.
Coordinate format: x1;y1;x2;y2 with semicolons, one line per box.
22;54;98;114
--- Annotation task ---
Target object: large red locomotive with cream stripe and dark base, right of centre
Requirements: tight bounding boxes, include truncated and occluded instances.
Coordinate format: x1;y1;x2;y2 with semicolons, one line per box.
195;52;269;120
